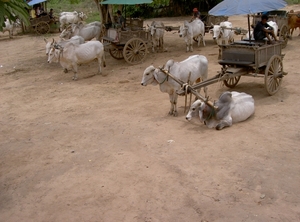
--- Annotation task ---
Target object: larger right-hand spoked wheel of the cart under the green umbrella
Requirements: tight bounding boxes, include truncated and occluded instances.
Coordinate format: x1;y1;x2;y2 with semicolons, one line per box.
123;38;147;65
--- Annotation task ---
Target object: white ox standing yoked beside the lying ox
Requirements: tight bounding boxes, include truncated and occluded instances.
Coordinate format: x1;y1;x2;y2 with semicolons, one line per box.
141;55;208;116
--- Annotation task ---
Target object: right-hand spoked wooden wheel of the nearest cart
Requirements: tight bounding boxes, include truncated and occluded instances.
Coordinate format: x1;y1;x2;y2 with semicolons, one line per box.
265;55;283;96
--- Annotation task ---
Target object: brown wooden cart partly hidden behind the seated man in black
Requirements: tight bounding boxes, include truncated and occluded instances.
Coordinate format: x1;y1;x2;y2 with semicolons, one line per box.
252;10;289;48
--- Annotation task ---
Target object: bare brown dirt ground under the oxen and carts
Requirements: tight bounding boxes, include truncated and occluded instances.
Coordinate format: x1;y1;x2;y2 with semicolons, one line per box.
0;6;300;222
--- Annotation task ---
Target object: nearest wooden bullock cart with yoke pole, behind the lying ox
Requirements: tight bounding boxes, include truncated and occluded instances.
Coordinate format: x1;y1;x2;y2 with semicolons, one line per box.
161;41;287;105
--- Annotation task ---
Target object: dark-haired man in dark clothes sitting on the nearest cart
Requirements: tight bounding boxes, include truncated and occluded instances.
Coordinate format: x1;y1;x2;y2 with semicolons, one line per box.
254;14;277;43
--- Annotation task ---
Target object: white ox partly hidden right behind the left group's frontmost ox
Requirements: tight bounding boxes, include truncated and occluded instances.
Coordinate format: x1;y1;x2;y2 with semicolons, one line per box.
59;21;102;41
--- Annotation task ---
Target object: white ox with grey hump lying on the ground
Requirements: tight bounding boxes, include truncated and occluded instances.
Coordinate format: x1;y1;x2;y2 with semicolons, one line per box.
186;91;255;130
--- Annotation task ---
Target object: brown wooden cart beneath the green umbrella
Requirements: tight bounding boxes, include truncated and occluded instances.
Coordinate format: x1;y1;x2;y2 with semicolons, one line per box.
103;22;150;65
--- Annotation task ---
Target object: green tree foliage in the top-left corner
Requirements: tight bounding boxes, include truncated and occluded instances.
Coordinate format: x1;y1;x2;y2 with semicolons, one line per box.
0;0;30;31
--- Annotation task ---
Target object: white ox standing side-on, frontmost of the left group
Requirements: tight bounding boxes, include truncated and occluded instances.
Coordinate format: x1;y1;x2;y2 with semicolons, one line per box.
48;41;106;80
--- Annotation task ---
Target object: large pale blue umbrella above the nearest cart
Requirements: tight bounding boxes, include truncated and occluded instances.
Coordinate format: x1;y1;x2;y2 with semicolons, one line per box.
208;0;287;16
